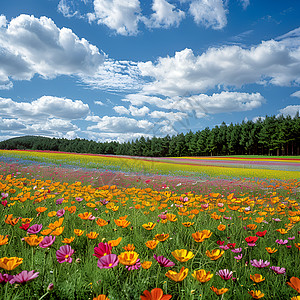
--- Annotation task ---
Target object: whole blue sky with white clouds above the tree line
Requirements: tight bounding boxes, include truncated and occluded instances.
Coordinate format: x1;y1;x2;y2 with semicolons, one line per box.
0;0;300;142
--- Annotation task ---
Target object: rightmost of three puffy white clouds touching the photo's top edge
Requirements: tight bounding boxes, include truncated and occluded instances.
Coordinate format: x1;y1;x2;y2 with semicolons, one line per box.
189;0;228;29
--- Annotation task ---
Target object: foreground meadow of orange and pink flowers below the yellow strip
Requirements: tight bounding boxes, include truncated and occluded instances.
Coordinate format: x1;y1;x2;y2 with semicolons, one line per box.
0;154;300;300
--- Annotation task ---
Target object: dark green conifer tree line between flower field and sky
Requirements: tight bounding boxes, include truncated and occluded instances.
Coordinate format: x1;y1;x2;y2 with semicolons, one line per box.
0;112;300;157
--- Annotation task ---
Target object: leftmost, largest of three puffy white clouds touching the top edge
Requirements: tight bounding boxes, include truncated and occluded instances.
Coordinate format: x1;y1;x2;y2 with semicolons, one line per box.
88;0;141;35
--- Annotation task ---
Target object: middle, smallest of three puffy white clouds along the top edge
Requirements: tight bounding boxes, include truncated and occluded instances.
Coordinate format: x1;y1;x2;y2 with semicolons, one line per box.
144;0;185;28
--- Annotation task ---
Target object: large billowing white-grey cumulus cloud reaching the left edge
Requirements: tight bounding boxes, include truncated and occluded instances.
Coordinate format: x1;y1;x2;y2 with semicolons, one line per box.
0;14;104;86
